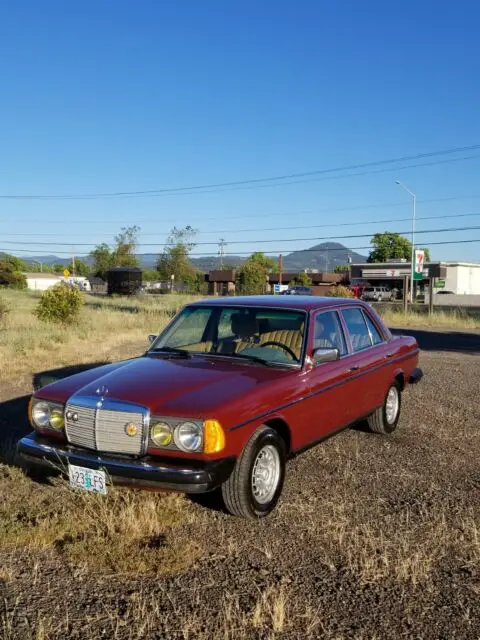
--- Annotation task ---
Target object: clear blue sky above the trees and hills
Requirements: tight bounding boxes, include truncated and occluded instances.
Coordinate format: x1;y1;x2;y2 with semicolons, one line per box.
0;0;480;261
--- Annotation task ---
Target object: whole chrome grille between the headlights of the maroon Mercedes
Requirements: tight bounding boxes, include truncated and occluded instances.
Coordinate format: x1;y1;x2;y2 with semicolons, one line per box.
65;396;148;455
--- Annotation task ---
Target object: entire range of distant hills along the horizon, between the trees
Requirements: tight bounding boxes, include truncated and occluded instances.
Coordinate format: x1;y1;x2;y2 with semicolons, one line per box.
15;242;367;272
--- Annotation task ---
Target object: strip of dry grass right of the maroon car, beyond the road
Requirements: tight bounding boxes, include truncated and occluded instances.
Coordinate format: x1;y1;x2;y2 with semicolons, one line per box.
378;308;480;329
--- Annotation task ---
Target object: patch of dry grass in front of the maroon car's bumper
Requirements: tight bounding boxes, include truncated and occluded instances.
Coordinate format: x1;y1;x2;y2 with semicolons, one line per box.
0;467;201;574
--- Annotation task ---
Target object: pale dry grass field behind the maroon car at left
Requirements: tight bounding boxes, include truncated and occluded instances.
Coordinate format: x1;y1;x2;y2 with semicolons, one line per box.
0;290;201;392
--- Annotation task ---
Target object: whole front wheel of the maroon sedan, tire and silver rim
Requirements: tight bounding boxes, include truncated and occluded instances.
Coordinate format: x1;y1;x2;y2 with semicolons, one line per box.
222;426;287;519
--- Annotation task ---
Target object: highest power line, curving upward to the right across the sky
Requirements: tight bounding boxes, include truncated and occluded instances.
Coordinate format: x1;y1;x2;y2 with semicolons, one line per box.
0;144;480;200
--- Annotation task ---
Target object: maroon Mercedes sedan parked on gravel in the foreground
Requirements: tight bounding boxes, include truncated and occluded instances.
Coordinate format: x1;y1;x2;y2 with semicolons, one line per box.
18;296;422;518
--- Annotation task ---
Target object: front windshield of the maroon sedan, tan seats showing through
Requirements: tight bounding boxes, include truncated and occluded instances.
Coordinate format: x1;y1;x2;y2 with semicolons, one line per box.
149;305;305;365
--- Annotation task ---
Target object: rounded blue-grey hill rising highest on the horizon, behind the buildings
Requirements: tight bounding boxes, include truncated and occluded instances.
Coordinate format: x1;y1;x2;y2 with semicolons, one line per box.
283;242;367;271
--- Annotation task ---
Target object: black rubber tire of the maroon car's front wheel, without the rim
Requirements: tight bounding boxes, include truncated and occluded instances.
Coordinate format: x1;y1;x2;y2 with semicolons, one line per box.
222;426;287;519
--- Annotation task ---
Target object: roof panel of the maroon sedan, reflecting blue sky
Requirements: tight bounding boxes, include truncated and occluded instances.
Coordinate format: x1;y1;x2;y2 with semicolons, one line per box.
188;295;368;311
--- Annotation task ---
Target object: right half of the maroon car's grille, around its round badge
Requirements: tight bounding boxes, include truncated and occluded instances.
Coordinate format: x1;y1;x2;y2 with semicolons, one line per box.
96;409;143;455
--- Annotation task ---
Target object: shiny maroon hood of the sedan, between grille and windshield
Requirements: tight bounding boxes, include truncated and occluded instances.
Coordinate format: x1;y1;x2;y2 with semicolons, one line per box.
36;355;298;418
